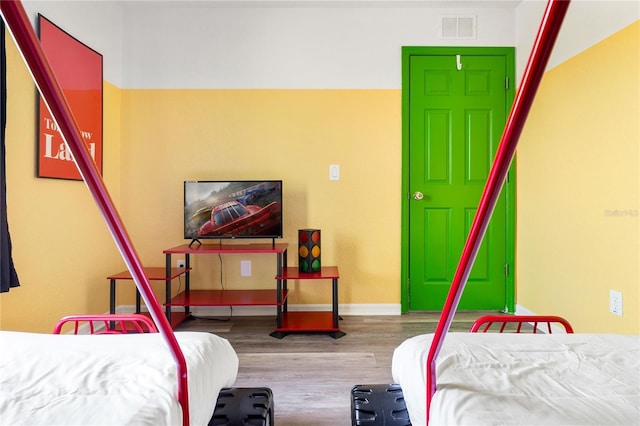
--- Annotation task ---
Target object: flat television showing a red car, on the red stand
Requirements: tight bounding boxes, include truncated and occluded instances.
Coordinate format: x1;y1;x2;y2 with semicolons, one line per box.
184;180;282;240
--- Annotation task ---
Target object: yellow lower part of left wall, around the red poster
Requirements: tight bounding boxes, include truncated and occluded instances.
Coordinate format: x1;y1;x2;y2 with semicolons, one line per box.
0;36;122;332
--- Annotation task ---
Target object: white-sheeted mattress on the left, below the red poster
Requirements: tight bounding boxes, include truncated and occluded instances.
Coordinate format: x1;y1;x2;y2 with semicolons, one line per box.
0;331;238;426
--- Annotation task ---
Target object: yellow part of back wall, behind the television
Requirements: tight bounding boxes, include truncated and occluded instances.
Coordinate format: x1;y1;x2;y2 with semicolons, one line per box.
122;90;401;304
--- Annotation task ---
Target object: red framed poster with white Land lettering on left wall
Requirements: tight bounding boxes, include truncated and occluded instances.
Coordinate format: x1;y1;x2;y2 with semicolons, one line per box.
38;14;102;180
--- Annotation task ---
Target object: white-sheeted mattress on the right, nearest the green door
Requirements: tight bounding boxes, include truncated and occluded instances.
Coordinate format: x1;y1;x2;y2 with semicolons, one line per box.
392;333;640;426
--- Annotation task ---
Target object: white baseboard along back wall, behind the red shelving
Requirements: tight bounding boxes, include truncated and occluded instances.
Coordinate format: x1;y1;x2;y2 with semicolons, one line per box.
116;303;401;317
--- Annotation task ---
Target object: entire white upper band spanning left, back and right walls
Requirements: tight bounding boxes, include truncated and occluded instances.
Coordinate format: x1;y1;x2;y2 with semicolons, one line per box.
11;0;640;89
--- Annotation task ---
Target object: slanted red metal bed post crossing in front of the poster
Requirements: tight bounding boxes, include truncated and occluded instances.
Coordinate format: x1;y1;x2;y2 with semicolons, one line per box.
0;0;189;426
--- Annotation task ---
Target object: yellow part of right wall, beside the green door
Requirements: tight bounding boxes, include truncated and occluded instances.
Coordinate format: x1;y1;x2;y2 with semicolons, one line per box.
517;22;640;334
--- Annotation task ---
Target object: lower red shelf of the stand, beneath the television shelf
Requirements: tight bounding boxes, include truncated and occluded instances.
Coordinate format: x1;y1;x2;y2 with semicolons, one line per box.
165;290;287;306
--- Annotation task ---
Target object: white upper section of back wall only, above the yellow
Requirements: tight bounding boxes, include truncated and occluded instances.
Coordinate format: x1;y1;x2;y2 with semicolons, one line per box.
124;1;515;89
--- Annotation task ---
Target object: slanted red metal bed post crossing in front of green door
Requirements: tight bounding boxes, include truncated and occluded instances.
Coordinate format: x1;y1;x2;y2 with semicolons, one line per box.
426;0;570;424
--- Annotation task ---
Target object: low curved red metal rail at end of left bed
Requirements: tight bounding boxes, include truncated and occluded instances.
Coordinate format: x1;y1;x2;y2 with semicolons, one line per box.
53;314;158;334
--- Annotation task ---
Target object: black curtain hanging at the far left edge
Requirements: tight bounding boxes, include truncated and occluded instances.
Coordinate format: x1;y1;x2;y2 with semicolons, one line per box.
0;19;20;293
